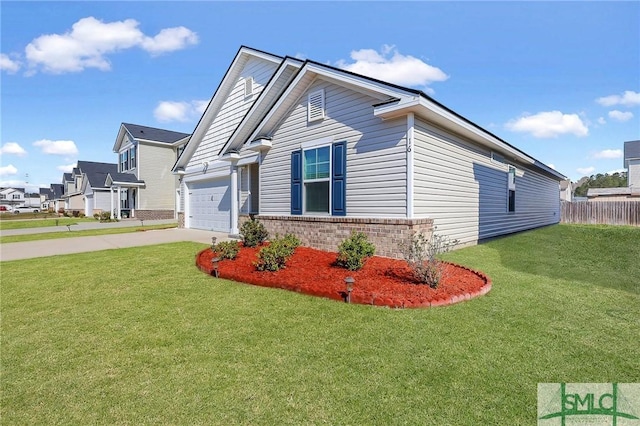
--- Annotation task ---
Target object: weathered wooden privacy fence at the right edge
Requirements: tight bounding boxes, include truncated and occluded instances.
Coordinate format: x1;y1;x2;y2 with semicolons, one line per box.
560;201;640;226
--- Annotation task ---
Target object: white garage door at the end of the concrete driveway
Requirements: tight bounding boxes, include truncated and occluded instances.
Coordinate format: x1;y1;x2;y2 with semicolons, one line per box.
189;178;231;232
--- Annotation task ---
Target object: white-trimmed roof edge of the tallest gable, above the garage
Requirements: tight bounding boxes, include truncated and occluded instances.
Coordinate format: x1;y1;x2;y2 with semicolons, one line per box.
173;46;283;171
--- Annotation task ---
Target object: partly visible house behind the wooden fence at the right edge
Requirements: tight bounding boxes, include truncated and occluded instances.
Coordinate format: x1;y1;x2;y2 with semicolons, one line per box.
587;140;640;201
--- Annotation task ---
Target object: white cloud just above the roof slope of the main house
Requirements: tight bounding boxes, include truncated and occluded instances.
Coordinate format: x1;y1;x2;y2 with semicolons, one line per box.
336;45;449;87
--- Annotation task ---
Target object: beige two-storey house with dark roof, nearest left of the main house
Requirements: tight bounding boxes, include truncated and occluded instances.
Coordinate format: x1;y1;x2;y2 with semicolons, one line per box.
107;123;189;219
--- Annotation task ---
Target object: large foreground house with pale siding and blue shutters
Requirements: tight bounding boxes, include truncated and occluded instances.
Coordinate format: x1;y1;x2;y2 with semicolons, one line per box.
174;47;566;257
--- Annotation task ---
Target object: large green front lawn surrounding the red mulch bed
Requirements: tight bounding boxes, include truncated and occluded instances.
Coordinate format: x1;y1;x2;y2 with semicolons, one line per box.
0;225;640;425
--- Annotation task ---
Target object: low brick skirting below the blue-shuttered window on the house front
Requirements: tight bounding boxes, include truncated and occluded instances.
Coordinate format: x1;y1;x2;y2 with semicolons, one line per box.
239;215;433;259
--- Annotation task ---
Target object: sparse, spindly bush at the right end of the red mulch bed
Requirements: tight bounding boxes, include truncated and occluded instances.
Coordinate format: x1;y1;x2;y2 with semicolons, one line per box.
404;232;459;288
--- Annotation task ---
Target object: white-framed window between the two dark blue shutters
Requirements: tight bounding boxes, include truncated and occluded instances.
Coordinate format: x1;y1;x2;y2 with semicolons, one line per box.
302;145;331;214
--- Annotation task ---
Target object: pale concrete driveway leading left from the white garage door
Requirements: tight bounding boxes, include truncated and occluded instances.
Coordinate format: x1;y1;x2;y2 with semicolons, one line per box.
0;226;230;262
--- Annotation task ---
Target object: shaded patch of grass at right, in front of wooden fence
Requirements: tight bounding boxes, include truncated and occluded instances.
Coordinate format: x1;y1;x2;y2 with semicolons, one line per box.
486;224;640;294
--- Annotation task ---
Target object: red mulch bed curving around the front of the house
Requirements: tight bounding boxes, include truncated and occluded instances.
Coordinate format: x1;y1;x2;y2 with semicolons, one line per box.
196;247;491;308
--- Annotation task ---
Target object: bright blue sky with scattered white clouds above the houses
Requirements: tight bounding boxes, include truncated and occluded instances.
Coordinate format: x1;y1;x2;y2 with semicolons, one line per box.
0;1;640;188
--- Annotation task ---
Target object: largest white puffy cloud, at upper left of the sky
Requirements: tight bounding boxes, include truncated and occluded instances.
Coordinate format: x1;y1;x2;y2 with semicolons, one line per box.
25;17;198;74
